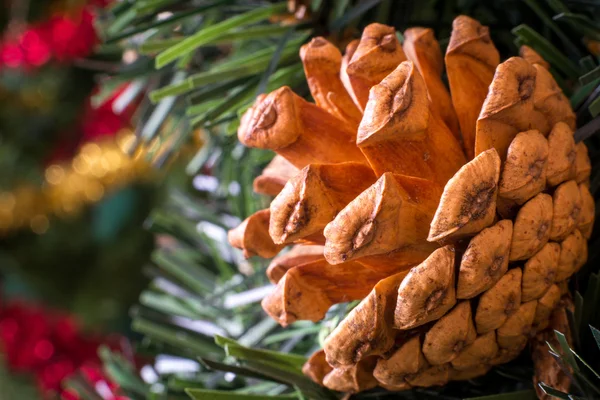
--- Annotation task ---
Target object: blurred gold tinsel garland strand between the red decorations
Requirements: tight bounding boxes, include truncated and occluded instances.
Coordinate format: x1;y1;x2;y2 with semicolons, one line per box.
0;129;152;237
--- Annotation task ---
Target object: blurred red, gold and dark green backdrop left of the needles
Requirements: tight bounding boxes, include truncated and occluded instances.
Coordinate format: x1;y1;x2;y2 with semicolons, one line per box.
0;0;160;400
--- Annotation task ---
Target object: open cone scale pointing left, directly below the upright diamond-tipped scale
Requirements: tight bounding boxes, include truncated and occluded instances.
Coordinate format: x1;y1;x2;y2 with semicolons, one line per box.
324;173;441;266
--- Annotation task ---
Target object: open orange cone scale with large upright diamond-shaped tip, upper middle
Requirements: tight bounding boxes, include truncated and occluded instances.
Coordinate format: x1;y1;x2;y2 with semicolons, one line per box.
357;61;466;186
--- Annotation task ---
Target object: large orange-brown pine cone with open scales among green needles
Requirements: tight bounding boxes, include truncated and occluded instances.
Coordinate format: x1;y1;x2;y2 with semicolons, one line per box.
230;16;595;392
